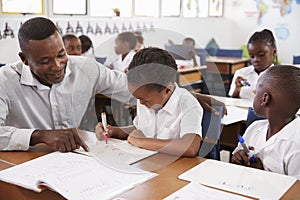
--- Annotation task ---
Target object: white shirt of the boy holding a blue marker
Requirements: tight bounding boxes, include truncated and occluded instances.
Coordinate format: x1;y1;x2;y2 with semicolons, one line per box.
233;117;300;179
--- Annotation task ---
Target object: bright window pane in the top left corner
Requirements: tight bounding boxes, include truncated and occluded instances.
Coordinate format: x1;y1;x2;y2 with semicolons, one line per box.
1;0;44;14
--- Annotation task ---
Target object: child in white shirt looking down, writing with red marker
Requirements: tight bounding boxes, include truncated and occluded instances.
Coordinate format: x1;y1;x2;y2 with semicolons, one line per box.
96;48;203;157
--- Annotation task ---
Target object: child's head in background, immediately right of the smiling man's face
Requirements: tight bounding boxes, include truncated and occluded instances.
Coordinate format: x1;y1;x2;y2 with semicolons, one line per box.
62;34;81;56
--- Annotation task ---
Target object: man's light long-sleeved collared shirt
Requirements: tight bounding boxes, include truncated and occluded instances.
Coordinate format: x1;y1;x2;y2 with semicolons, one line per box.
0;56;131;150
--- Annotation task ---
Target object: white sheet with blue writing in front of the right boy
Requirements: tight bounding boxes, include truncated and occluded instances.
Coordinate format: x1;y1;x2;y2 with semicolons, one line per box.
179;159;297;199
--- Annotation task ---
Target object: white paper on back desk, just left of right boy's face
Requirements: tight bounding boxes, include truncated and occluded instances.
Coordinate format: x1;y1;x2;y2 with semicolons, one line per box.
221;106;248;125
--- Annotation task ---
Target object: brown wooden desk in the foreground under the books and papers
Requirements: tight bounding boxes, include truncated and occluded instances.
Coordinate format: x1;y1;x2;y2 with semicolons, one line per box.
0;145;300;200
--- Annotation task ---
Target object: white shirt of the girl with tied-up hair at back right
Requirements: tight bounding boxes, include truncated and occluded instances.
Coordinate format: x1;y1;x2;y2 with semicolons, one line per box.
228;64;273;101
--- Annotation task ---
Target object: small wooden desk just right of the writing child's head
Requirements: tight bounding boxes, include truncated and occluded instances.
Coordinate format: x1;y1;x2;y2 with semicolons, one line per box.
176;66;206;92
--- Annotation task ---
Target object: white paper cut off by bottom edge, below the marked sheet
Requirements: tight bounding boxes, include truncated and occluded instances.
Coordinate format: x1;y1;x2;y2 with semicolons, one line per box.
164;182;249;200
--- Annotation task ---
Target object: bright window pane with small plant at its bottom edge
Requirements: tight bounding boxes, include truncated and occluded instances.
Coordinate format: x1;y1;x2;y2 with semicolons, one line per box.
90;0;132;17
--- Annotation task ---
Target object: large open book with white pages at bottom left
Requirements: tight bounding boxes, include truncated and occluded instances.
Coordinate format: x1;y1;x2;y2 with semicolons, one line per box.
0;152;157;200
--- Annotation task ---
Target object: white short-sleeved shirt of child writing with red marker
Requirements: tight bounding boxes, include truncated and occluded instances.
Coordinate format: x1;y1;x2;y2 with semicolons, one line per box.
133;85;203;139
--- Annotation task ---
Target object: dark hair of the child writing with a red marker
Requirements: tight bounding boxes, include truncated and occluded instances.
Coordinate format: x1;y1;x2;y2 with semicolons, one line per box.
127;47;177;91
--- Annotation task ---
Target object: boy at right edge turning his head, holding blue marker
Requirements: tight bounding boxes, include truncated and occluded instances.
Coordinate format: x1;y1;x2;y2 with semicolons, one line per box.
232;65;300;179
